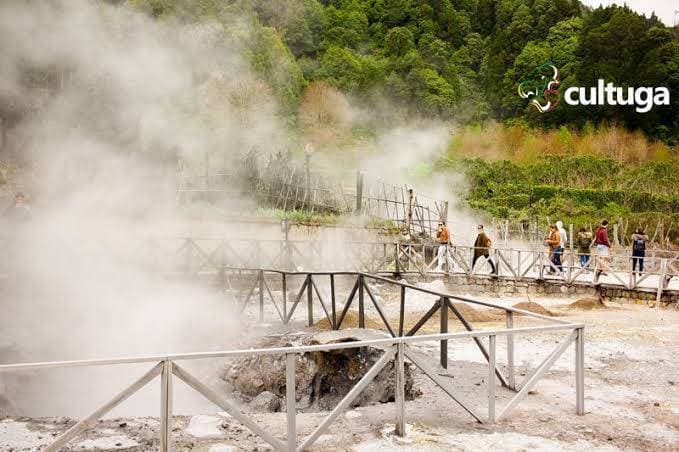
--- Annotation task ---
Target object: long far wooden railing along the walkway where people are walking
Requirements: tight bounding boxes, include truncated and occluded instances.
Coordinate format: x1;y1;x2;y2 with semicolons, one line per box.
135;238;679;297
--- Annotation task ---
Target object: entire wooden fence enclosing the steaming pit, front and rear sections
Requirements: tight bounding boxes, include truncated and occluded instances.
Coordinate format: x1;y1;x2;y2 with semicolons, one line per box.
0;269;585;452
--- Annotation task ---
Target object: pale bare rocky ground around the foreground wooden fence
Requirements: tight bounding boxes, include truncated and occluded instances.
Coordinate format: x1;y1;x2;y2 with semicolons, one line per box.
0;282;679;452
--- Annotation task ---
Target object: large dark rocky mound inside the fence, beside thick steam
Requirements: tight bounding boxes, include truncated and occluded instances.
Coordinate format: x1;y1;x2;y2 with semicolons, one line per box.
223;329;421;412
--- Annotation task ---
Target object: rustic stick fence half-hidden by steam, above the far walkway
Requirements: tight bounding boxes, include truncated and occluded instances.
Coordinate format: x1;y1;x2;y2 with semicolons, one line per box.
177;156;448;234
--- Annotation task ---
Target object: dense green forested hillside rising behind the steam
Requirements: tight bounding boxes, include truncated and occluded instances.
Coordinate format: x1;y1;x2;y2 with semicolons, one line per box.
130;0;679;144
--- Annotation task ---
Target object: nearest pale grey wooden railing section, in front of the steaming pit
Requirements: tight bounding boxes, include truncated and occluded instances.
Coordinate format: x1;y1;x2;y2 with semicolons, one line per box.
0;323;584;452
